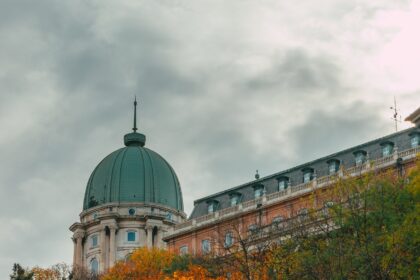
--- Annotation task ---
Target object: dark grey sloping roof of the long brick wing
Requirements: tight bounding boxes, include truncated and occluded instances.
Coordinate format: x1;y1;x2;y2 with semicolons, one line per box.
190;127;420;219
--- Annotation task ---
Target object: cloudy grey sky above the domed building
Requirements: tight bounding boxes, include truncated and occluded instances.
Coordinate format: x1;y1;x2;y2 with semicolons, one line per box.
0;0;420;279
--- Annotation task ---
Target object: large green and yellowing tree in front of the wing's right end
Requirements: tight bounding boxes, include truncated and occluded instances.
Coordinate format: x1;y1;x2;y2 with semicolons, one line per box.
271;160;420;279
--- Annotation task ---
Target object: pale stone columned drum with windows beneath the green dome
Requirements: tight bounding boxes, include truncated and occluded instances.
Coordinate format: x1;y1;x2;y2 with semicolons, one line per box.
70;203;186;272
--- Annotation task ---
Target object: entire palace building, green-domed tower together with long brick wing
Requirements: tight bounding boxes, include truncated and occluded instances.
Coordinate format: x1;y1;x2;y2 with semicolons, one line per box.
70;102;420;272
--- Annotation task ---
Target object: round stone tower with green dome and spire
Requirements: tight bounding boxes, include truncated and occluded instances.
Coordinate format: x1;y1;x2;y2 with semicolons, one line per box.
70;101;186;272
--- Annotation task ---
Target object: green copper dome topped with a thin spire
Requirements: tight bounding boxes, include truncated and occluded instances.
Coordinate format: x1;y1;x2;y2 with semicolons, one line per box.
83;101;184;211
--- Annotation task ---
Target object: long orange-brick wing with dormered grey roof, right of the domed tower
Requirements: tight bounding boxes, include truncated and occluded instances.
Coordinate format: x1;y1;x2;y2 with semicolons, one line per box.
164;108;420;255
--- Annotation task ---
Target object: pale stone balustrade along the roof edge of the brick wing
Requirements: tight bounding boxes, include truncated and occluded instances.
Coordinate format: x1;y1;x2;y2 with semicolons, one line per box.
174;147;420;234
